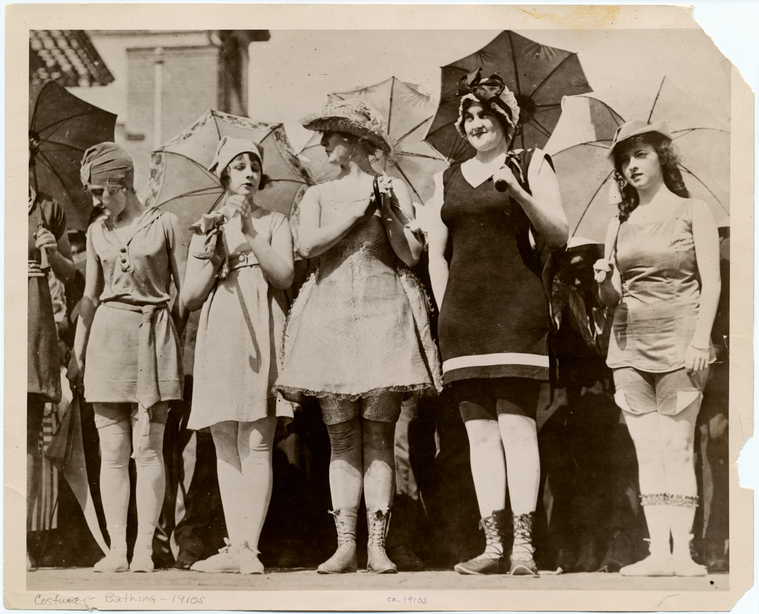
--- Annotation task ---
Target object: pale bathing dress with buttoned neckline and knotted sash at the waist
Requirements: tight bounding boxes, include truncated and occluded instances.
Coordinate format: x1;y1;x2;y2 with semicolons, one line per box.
84;208;182;403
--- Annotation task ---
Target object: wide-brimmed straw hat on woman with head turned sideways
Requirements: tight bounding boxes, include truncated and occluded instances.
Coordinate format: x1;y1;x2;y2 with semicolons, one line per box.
300;98;392;153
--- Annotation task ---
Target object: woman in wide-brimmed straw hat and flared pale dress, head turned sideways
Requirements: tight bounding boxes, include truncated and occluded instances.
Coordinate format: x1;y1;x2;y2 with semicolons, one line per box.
276;99;440;574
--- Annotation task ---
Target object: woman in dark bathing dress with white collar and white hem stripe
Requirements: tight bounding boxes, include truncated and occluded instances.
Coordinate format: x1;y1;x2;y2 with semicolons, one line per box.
428;71;568;575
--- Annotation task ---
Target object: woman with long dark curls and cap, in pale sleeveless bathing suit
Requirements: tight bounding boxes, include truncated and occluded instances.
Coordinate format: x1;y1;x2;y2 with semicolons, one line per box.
594;121;720;576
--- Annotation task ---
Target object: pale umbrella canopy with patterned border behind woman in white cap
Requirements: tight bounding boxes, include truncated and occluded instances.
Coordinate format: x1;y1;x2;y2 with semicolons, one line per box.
146;109;313;253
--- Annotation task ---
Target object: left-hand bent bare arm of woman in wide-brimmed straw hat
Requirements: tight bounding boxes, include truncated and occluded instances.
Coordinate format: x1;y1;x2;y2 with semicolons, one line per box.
297;186;376;258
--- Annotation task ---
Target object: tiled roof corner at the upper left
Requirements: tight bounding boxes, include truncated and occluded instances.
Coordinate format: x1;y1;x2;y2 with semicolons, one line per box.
29;30;113;87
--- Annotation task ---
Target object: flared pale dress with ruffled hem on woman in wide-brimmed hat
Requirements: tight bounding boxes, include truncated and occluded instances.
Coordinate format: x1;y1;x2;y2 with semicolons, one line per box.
276;182;442;401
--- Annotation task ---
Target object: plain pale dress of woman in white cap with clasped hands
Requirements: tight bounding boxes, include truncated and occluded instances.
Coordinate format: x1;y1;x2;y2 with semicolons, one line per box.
187;209;292;430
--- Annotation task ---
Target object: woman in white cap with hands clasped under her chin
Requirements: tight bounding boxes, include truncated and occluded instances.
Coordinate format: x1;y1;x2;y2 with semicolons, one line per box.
182;136;293;574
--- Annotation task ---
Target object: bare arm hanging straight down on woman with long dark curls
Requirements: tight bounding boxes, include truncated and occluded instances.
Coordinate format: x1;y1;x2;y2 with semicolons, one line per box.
685;201;721;370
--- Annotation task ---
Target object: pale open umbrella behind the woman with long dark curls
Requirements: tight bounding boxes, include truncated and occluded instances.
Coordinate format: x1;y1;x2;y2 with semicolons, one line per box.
546;78;730;242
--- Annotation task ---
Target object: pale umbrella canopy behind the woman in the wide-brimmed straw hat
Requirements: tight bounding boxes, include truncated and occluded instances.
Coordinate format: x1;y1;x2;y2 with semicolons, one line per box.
299;77;447;203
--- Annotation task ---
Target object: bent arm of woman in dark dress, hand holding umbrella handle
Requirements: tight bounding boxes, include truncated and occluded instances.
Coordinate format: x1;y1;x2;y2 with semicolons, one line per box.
494;149;569;247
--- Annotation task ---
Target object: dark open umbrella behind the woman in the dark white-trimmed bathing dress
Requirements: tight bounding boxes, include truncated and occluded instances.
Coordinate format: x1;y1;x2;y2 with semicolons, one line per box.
425;30;593;162
